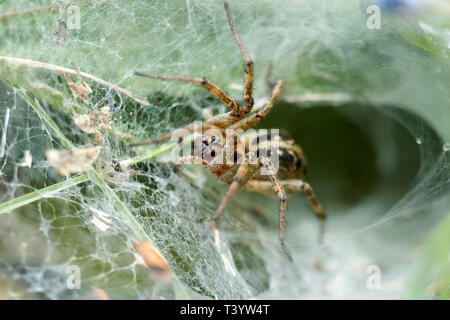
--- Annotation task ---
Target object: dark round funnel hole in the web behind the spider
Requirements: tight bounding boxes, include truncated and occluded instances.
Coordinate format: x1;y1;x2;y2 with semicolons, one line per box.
261;103;439;208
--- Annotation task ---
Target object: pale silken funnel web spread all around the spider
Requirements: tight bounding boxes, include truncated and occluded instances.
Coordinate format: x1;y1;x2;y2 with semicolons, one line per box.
0;0;450;299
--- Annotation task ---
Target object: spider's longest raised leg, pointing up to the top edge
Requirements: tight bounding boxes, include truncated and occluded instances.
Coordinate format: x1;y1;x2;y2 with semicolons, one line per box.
224;2;254;114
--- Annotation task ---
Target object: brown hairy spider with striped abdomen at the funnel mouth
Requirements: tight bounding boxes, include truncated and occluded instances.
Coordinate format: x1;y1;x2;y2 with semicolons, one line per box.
130;2;326;261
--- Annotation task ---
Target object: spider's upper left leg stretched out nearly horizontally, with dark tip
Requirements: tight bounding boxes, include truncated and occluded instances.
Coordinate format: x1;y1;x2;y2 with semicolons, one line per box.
134;72;242;114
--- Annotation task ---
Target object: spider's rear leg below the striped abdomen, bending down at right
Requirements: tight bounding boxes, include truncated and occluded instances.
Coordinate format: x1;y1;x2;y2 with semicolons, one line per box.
245;179;327;242
